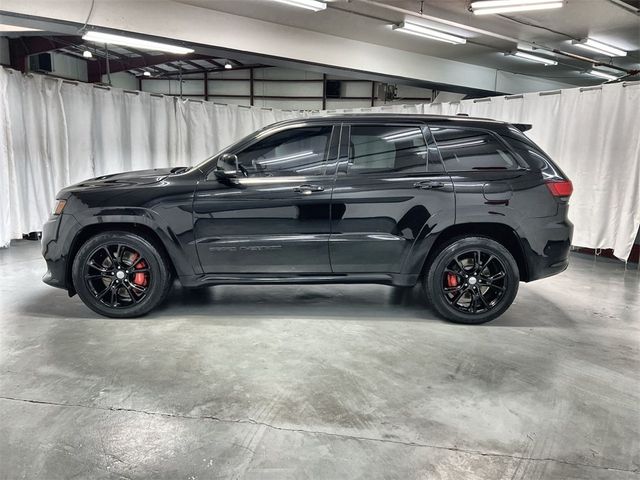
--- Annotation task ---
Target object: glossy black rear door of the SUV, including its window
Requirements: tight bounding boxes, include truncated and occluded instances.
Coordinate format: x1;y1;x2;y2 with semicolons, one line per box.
329;122;455;273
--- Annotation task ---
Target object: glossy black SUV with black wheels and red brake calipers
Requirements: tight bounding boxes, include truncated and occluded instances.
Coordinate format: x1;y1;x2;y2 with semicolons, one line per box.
42;115;573;323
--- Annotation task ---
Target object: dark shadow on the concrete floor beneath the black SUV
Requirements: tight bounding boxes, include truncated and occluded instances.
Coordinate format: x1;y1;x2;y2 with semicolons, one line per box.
20;284;573;328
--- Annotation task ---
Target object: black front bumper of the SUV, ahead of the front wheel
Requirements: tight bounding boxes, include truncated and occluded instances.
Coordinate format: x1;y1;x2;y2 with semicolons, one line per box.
42;213;81;294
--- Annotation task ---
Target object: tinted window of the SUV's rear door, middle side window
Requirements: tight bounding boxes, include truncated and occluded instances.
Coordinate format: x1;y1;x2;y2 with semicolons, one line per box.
348;125;427;174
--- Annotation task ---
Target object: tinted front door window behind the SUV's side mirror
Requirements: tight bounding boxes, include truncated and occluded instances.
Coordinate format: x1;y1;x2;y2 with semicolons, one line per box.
238;126;332;176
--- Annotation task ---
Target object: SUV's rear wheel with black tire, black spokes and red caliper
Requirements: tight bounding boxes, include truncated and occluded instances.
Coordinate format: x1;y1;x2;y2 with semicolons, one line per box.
423;237;520;324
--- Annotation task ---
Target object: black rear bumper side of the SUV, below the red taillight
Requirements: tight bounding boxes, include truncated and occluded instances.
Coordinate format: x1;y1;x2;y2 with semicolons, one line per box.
523;219;573;282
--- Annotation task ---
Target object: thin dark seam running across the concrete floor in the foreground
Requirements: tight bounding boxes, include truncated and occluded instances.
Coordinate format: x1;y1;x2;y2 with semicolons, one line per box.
0;396;640;473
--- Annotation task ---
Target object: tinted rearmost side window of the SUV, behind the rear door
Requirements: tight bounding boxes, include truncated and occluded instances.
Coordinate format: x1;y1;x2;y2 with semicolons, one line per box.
430;127;518;172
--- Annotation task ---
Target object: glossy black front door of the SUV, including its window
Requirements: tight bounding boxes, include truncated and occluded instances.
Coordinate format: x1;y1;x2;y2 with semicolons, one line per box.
194;123;338;274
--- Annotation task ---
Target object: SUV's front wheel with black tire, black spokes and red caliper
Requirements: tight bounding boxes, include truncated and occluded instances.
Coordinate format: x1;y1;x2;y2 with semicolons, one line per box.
72;231;172;318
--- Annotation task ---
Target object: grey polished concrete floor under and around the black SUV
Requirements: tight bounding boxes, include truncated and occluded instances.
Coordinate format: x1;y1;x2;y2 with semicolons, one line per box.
0;241;640;480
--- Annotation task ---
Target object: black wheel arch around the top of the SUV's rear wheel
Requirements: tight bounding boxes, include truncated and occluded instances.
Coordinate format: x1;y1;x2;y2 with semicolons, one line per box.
421;223;529;282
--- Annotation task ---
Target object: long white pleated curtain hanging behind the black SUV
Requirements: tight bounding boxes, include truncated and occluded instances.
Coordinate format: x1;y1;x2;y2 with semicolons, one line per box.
0;68;640;259
